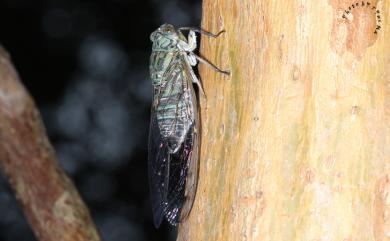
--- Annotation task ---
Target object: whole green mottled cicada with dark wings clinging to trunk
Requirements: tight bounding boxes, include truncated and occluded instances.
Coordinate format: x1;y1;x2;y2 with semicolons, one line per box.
148;24;229;227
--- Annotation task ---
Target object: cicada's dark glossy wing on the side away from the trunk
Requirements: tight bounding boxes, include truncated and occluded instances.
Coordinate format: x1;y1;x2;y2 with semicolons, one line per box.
148;109;169;228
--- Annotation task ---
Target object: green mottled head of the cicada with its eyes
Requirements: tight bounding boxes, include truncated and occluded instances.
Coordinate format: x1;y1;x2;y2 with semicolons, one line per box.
150;23;179;51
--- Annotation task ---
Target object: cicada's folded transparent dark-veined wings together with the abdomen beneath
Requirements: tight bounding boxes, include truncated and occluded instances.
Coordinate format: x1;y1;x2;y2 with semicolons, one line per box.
148;53;199;227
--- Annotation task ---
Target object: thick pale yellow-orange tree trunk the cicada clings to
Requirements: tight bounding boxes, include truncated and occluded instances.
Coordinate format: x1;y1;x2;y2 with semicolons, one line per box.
178;0;390;241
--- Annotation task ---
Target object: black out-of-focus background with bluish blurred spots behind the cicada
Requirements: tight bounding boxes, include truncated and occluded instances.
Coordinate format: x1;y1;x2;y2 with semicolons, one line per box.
0;0;201;241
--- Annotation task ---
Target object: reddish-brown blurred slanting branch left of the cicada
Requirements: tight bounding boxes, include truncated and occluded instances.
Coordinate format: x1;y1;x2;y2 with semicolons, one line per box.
0;48;100;241
